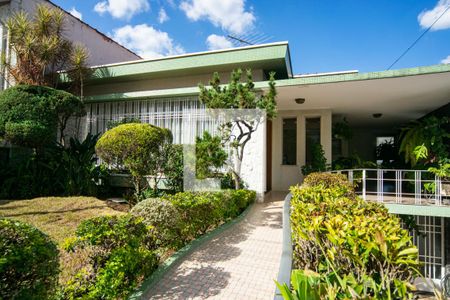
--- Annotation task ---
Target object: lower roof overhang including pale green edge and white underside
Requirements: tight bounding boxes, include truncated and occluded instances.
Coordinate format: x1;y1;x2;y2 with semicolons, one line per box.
85;65;450;128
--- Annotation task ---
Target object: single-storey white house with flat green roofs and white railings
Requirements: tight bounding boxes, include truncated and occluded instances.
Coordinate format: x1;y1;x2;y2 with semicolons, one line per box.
64;42;450;288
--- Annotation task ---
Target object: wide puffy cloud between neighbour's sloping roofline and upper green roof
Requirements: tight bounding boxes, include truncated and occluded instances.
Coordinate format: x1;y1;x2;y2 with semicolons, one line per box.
111;24;184;58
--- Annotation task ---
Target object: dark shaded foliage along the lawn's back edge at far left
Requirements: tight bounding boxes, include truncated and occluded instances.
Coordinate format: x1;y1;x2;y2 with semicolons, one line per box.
0;134;108;199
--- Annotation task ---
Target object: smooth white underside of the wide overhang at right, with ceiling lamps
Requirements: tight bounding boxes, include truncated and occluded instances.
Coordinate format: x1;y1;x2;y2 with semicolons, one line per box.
277;72;450;128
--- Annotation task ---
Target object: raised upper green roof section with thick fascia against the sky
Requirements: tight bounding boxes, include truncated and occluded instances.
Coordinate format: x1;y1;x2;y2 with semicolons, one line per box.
61;42;292;84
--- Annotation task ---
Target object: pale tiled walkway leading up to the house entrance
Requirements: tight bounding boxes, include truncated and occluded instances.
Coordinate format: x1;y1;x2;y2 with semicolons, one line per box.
145;193;284;300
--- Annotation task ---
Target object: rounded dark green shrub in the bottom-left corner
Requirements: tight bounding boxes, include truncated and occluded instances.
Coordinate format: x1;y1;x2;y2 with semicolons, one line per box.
0;219;59;299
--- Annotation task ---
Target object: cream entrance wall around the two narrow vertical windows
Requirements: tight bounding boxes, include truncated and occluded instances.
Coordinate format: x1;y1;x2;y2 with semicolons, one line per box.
272;109;332;191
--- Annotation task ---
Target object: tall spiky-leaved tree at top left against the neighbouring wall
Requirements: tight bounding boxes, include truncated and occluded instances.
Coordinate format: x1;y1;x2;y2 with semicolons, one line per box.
2;4;88;90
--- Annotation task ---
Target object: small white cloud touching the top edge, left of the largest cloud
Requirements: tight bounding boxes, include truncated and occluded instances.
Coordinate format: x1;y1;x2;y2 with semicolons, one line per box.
94;0;150;20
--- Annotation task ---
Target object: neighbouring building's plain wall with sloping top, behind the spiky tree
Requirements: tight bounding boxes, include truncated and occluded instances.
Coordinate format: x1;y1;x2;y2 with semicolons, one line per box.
0;0;141;90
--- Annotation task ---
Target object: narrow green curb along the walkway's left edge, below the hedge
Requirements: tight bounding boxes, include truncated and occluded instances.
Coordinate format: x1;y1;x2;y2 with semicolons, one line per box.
128;203;254;300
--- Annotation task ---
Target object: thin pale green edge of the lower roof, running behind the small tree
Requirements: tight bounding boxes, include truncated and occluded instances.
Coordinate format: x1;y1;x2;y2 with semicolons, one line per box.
85;64;450;102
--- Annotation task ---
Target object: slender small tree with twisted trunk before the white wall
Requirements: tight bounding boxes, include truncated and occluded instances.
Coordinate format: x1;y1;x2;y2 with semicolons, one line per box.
199;69;277;189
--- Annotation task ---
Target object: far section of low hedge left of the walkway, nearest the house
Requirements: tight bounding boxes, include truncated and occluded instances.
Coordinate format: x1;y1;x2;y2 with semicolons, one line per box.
131;190;256;249
